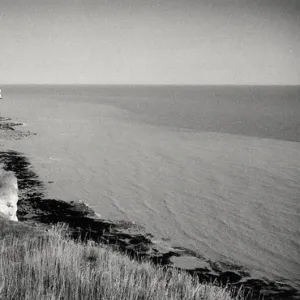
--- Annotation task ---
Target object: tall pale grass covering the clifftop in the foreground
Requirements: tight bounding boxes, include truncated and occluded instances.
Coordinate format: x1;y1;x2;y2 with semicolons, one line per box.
0;220;244;300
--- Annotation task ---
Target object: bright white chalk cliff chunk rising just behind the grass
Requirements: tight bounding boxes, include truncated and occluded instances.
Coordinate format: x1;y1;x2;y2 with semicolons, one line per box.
0;170;18;221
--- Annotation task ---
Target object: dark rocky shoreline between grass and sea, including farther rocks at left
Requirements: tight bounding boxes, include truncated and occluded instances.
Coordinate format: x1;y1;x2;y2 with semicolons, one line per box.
0;117;300;299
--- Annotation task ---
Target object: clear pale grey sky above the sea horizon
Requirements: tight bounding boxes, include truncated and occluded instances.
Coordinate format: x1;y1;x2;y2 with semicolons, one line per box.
0;0;300;85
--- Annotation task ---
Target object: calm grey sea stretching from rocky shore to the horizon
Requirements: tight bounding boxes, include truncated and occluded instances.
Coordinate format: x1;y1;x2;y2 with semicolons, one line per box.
0;86;300;288
